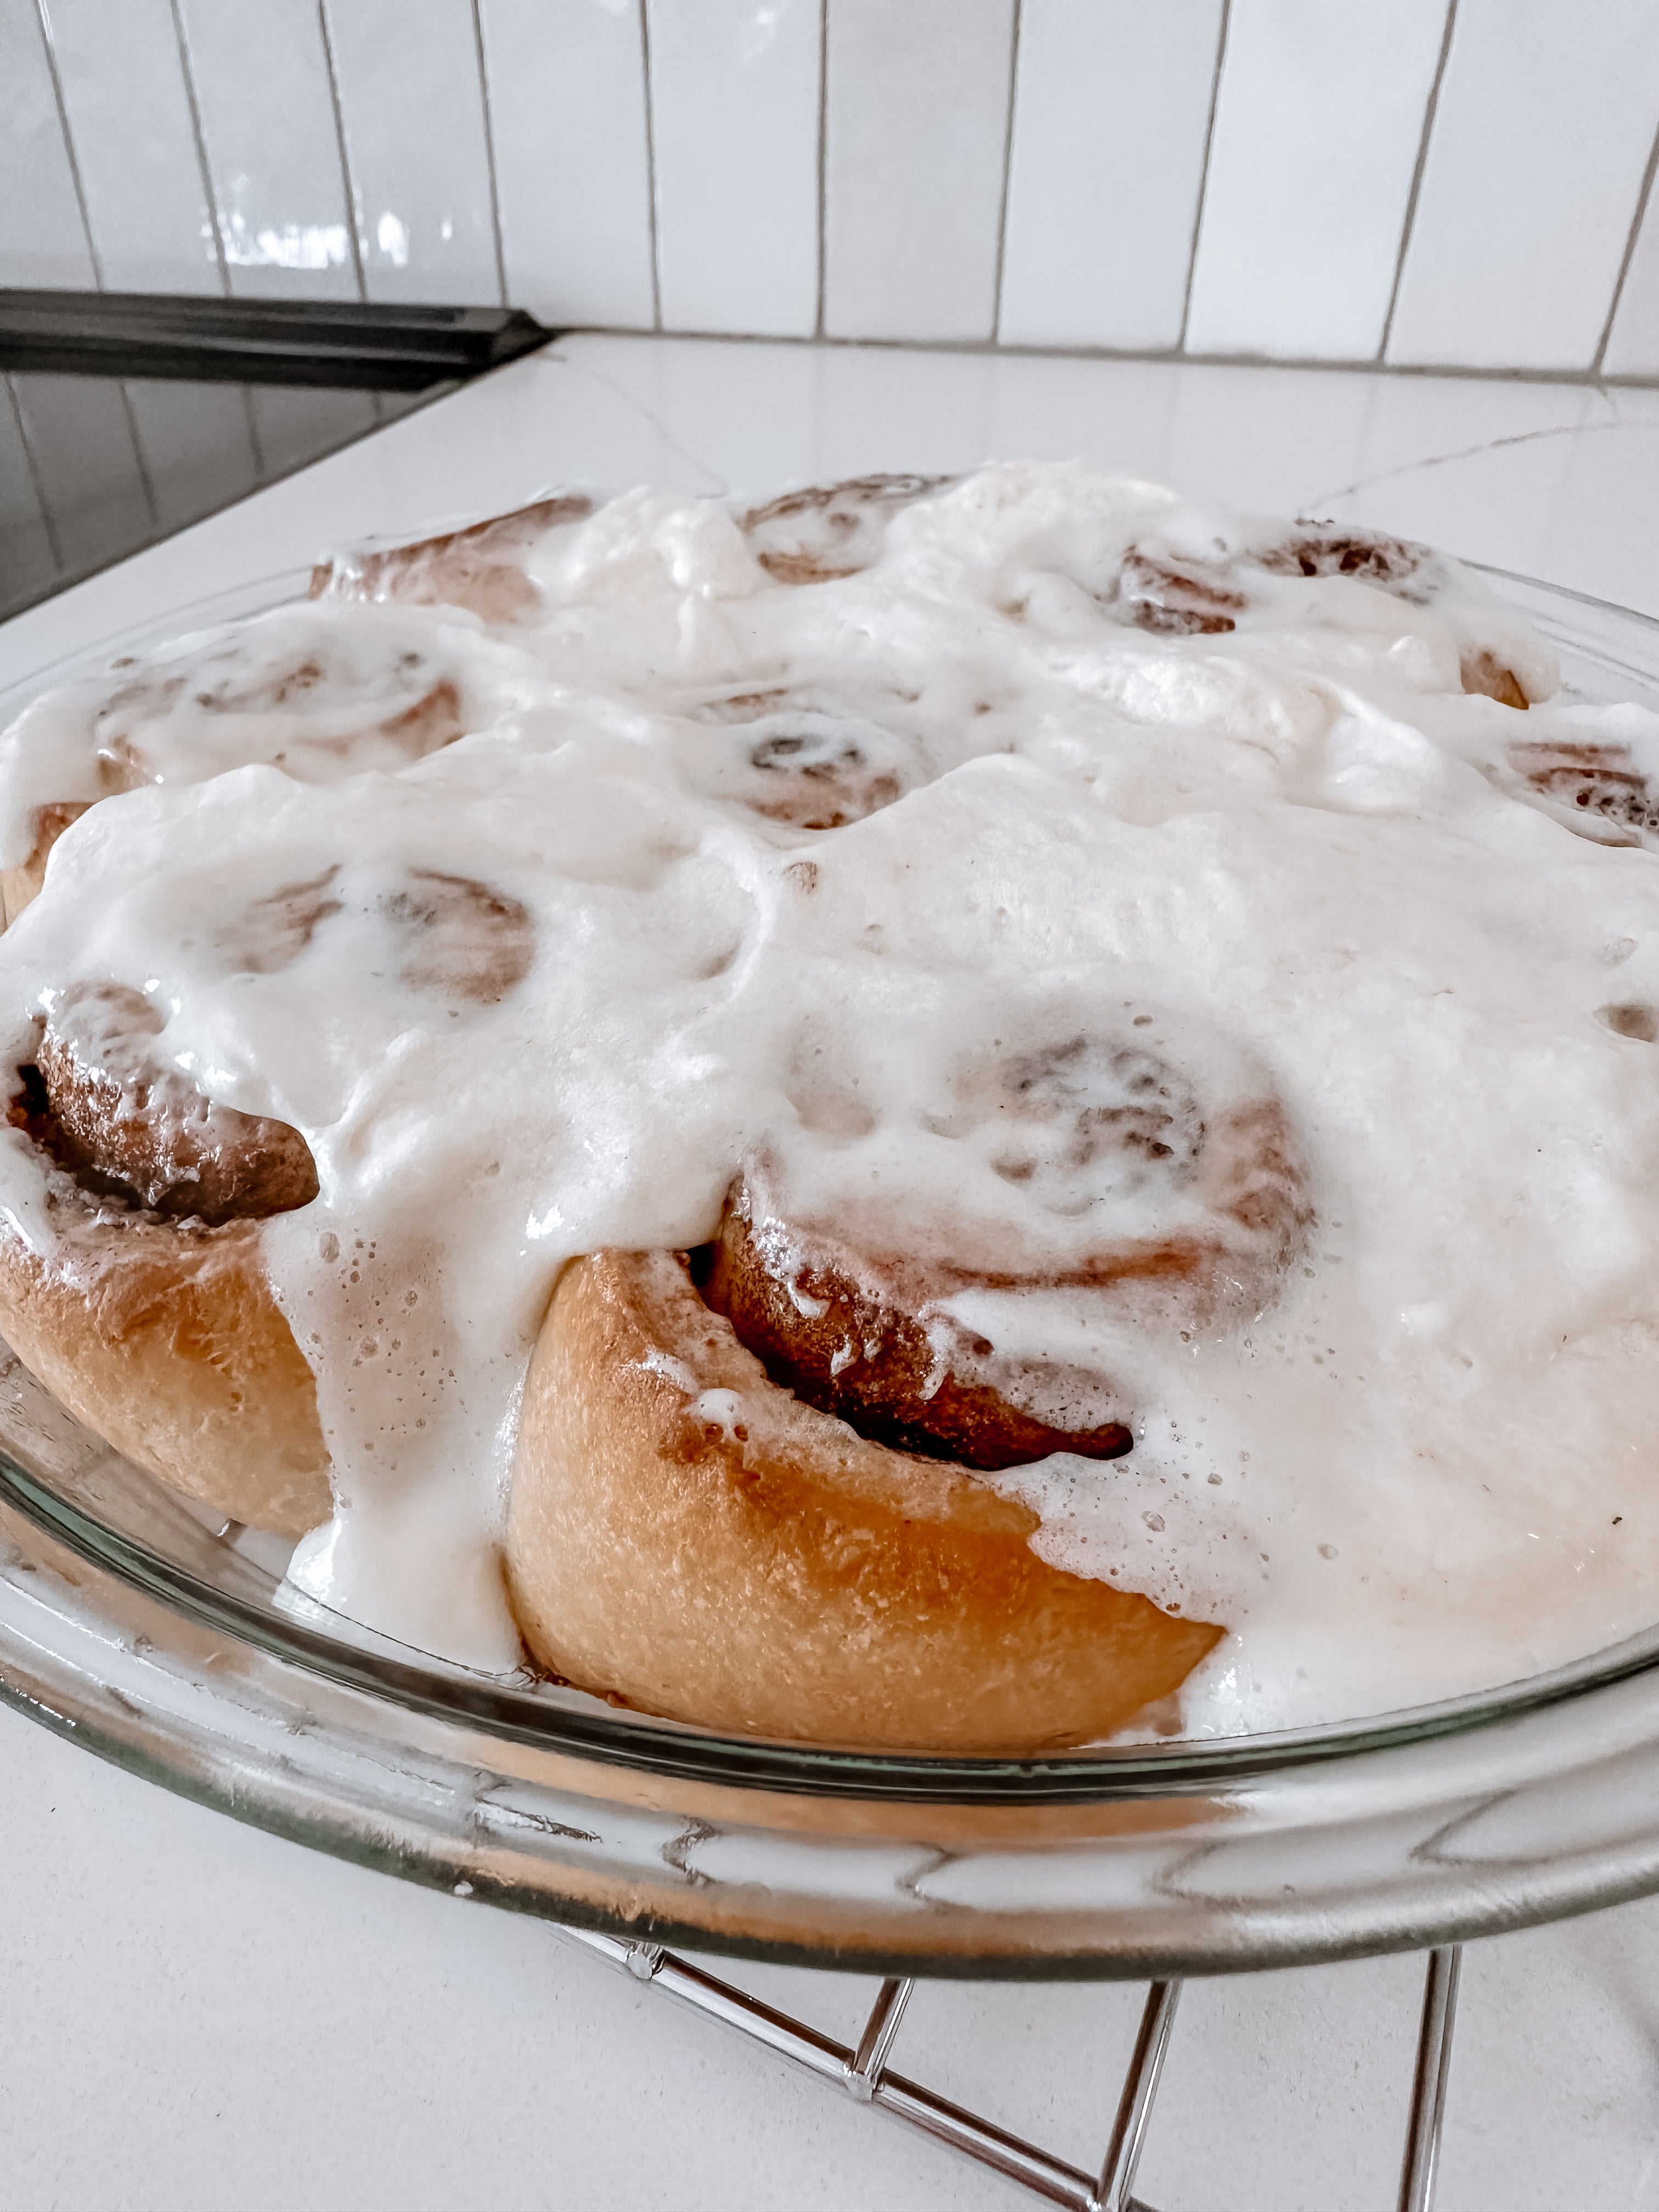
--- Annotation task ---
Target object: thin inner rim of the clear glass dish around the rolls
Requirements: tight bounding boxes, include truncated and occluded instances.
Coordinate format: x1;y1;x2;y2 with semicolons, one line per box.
0;562;1659;1805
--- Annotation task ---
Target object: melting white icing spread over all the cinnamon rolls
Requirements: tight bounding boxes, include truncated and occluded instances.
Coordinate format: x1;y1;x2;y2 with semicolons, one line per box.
0;467;1659;1732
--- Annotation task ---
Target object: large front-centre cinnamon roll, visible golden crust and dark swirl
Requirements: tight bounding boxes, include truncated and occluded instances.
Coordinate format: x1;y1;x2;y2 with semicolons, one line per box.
506;1026;1312;1752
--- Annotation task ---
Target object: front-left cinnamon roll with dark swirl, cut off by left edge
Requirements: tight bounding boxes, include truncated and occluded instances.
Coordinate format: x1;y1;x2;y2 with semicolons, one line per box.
0;984;330;1535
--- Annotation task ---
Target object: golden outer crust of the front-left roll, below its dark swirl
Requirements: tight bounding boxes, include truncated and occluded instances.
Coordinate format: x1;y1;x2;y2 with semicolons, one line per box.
0;1175;332;1535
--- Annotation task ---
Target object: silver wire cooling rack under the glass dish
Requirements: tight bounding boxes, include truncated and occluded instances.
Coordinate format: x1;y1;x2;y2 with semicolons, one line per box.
560;1927;1462;2212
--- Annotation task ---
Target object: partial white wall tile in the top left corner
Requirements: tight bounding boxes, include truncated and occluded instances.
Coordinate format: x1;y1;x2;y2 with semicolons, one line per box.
0;0;97;287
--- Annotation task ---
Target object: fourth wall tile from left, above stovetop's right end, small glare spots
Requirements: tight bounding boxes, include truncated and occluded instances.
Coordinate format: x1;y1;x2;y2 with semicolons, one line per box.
328;0;500;307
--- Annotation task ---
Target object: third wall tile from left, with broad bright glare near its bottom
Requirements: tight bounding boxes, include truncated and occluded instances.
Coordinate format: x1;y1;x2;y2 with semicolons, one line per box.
182;0;358;298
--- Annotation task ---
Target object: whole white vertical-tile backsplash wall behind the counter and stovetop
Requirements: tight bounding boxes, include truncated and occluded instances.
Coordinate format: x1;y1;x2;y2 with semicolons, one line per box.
0;0;1659;381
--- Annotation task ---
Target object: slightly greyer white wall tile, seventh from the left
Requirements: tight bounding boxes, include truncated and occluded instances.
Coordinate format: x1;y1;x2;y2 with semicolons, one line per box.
823;0;1013;341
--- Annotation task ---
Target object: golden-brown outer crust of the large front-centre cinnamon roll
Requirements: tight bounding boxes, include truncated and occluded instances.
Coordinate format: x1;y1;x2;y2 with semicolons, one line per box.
506;1252;1221;1754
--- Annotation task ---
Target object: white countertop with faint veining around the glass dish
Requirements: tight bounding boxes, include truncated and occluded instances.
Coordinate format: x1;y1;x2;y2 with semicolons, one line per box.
0;338;1659;2212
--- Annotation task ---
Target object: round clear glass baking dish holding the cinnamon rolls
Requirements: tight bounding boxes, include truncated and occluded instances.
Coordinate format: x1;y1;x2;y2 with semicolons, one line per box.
0;571;1659;1980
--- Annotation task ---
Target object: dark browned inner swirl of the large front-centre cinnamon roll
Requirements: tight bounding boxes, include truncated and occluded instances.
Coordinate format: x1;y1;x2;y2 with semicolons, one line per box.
692;1017;1312;1469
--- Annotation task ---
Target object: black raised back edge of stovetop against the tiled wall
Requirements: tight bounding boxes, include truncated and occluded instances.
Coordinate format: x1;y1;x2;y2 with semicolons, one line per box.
0;287;557;392
